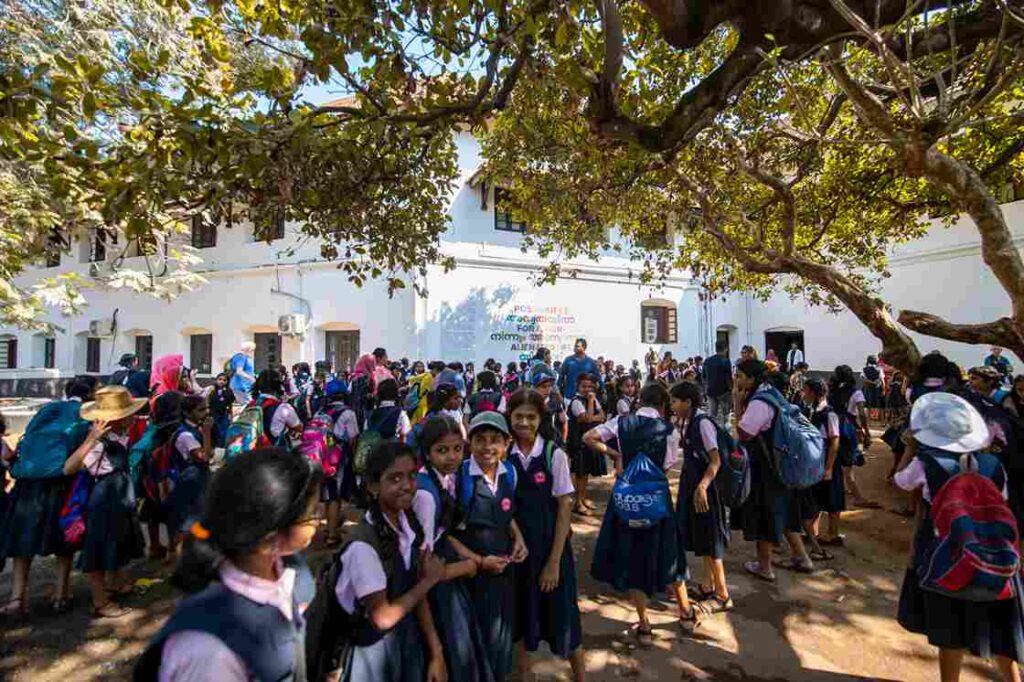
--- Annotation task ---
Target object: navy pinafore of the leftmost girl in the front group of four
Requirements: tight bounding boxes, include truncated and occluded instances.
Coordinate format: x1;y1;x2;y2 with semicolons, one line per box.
341;524;426;682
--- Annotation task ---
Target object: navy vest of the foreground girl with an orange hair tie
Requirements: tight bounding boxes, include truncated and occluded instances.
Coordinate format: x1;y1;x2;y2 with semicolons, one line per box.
134;557;315;682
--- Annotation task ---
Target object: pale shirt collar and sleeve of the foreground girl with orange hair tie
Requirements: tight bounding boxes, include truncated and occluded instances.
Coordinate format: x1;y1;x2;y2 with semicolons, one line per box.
157;561;296;682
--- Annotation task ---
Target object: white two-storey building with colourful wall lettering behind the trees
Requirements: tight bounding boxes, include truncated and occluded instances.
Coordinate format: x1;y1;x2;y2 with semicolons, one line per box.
0;133;1024;395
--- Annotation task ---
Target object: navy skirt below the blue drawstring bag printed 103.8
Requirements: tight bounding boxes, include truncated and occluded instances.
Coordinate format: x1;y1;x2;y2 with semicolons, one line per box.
590;506;687;597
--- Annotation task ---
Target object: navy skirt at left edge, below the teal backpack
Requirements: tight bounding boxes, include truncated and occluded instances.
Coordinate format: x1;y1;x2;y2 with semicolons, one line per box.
0;476;75;558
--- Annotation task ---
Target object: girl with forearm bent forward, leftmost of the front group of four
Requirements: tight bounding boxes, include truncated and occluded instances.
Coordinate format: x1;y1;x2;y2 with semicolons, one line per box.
334;440;445;682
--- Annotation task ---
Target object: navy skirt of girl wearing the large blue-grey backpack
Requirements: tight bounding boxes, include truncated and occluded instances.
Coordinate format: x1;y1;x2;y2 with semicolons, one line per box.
742;439;803;544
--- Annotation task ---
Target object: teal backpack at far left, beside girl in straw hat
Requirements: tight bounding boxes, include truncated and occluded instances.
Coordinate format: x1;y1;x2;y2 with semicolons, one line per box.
11;400;90;479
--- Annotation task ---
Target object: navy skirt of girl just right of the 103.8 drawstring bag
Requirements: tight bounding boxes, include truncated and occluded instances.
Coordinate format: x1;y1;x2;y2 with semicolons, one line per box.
676;455;730;559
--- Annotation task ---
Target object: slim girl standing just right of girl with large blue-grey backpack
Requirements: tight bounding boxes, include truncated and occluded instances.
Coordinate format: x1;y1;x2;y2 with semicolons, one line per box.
799;379;846;560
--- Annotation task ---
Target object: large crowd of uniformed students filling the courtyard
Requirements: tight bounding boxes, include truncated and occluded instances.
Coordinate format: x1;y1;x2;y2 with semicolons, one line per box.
0;339;1024;682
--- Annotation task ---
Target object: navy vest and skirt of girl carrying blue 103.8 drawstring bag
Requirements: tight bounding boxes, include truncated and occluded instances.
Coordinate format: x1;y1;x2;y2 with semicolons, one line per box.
590;408;686;597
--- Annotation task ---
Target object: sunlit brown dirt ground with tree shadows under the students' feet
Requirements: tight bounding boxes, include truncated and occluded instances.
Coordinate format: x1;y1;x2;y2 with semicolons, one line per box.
0;432;1011;682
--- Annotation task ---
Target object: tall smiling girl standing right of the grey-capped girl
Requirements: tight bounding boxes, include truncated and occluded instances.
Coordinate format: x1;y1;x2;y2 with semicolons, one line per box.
509;388;587;680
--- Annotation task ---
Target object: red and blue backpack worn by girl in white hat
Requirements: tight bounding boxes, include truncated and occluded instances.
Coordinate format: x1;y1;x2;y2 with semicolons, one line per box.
918;452;1020;602
